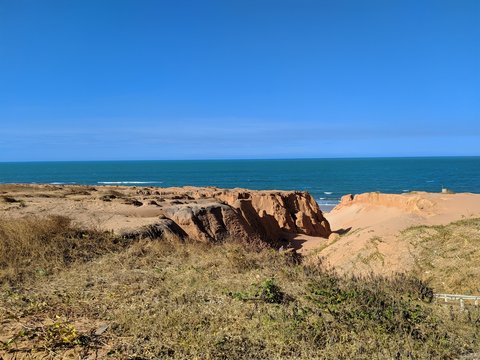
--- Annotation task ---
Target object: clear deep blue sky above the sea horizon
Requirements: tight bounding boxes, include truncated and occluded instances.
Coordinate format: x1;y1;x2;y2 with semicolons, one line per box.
0;0;480;161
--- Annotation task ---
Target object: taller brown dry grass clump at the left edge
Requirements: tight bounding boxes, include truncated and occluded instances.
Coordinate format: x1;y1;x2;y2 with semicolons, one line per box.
0;216;123;283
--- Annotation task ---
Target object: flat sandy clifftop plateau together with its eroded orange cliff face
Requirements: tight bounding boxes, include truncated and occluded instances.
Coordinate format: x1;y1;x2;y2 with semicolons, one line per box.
0;185;331;242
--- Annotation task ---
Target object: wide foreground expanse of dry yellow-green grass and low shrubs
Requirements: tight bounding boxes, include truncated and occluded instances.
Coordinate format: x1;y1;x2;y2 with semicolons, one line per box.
0;218;480;359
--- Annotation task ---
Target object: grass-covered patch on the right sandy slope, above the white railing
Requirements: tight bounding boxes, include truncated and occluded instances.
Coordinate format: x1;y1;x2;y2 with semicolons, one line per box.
402;219;480;295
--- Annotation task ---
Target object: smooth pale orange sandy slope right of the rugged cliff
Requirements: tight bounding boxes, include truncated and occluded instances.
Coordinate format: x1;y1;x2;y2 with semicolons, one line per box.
305;192;480;273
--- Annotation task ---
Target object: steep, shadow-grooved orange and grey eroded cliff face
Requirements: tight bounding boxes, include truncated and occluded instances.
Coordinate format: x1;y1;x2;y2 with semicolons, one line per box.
158;188;331;241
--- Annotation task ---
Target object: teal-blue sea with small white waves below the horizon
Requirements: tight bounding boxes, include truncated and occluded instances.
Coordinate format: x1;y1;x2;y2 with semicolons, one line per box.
0;157;480;211
